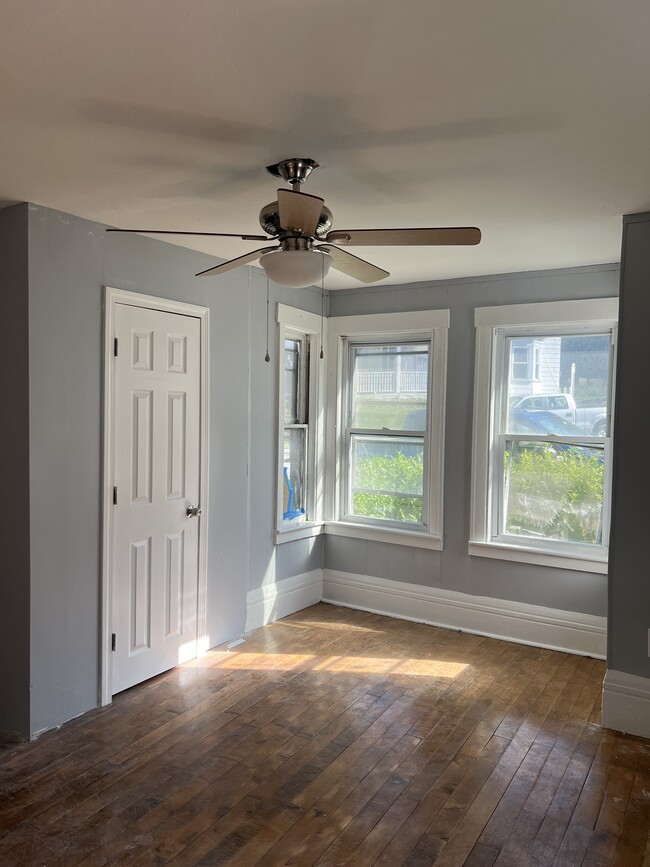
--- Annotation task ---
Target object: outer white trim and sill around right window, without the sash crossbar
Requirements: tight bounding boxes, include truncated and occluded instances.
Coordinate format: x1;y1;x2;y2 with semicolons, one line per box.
468;298;618;574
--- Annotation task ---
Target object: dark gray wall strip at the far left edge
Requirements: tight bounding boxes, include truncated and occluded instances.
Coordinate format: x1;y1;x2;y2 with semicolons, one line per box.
0;205;29;734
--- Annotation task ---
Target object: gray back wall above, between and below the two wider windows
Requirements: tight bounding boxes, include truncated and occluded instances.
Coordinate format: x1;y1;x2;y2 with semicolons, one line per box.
325;265;620;625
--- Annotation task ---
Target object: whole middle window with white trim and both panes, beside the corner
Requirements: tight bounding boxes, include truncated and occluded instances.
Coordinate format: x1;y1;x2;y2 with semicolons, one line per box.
326;311;449;548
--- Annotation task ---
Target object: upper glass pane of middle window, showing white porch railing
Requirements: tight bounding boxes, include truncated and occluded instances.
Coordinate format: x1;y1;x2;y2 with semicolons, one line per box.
350;343;429;431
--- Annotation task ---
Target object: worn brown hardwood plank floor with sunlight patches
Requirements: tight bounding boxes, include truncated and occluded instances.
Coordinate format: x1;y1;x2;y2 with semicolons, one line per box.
0;604;650;867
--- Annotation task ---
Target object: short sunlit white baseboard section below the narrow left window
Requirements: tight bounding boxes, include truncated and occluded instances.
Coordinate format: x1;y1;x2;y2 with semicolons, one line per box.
246;569;323;632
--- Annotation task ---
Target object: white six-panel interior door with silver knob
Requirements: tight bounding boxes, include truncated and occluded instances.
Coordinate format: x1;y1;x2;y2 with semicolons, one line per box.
112;304;201;693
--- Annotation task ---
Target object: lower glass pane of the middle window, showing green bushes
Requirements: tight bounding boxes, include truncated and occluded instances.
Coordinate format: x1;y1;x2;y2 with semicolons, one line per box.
349;434;424;524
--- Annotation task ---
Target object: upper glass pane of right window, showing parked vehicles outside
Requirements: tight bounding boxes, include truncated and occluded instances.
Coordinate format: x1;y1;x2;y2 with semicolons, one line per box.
503;334;610;437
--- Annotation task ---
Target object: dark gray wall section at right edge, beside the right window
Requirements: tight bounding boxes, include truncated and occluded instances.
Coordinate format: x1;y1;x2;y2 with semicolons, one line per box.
607;214;650;677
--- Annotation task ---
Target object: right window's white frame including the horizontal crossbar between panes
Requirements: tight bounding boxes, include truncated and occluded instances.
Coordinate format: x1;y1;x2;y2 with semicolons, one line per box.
469;298;618;573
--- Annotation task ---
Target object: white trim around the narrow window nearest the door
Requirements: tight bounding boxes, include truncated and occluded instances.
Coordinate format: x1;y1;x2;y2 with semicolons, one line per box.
275;304;327;545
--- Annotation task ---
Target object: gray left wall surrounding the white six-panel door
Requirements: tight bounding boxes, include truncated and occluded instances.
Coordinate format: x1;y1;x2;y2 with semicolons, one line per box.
12;205;320;734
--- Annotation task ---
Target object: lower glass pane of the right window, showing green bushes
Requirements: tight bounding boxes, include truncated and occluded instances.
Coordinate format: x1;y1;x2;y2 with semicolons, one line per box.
503;440;604;544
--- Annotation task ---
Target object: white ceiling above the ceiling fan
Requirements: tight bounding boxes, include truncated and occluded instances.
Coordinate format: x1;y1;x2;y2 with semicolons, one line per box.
0;0;650;288
